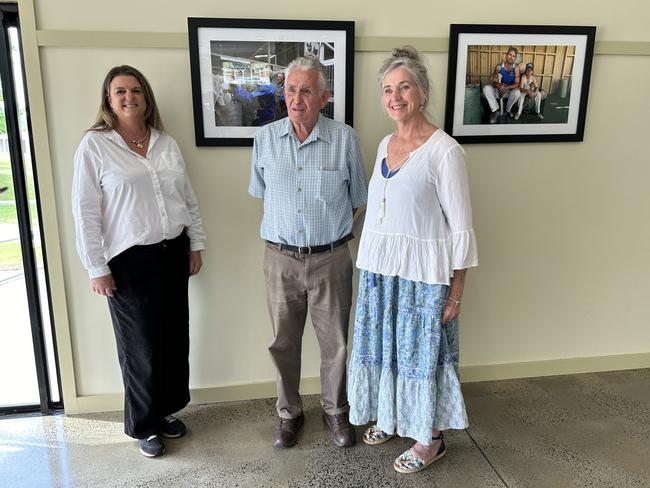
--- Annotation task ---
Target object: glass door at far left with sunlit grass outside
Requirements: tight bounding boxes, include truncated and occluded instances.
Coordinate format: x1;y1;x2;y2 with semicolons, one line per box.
0;4;62;413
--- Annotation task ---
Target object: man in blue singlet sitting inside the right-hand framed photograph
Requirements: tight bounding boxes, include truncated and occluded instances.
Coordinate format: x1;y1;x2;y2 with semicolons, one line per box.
483;46;520;124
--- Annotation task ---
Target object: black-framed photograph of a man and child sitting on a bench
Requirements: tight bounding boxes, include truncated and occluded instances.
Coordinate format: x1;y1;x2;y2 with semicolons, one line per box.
445;24;596;143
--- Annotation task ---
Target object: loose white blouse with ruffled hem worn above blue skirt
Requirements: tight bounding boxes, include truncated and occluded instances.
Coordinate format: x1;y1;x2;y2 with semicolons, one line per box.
357;129;478;285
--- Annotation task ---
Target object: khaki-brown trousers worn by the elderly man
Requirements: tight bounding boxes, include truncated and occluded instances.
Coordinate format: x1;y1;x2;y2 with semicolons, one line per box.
264;244;352;419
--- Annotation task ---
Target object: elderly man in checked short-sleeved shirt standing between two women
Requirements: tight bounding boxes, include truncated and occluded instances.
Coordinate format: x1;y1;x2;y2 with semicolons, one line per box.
248;58;367;447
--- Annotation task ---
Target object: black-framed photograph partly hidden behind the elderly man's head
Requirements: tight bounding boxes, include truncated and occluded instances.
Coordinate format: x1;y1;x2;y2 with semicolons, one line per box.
188;17;354;146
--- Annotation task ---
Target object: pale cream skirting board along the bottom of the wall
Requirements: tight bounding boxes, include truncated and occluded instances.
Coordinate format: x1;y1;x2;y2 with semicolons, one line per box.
65;353;650;414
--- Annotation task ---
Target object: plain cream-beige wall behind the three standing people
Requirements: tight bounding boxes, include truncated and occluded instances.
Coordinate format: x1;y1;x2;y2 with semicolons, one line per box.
19;0;650;411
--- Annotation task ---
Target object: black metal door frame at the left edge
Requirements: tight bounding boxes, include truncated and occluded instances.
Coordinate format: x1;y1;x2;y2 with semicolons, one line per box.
0;3;63;414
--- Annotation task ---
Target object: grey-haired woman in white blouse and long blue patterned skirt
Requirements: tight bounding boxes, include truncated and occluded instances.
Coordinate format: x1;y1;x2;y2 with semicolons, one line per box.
348;46;478;473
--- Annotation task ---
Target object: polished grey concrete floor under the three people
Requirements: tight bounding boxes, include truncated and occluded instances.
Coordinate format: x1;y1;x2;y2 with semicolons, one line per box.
0;370;650;488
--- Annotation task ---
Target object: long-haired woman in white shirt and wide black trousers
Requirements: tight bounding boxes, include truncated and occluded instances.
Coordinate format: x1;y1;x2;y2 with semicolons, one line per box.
72;66;205;457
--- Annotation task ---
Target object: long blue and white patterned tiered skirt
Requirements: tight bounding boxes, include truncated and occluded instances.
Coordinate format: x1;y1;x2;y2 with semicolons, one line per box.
348;270;468;444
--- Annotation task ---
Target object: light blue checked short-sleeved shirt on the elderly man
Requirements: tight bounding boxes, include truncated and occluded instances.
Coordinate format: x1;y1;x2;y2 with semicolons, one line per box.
248;115;368;246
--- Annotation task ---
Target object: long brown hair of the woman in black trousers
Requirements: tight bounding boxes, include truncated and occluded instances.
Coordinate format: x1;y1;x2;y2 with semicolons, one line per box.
88;64;165;132
